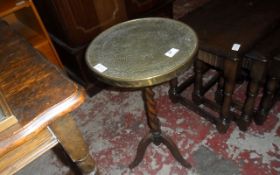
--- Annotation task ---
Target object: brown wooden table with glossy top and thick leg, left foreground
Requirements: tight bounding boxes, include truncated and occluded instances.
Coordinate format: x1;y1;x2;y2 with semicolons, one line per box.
0;21;96;174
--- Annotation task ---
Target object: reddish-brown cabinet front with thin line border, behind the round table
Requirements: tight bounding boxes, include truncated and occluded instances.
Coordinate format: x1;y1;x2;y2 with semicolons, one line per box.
35;0;127;47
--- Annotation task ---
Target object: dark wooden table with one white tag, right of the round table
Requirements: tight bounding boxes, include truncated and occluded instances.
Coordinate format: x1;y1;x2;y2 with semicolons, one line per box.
173;0;280;133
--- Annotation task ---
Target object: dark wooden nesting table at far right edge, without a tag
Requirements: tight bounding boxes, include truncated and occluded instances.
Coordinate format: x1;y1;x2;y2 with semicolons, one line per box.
246;25;280;125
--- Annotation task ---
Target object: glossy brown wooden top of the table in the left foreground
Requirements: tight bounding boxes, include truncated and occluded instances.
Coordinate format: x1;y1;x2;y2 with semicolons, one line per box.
0;21;84;155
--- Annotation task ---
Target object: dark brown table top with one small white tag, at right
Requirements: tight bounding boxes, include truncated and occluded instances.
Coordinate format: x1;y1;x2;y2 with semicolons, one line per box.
180;0;280;57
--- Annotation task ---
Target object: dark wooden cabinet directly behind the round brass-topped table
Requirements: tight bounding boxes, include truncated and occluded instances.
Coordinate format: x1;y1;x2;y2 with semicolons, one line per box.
34;0;173;95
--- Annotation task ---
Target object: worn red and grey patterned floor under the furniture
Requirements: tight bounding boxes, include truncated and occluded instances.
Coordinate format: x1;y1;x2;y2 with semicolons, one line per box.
17;0;280;175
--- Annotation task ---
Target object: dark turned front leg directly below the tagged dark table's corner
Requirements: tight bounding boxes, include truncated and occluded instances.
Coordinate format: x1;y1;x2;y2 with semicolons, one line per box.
217;57;239;133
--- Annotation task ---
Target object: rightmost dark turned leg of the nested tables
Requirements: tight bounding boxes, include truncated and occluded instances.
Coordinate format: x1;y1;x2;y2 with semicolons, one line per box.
254;77;279;125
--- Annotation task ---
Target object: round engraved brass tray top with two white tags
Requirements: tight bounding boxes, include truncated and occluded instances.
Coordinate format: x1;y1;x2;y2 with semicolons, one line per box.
86;18;198;88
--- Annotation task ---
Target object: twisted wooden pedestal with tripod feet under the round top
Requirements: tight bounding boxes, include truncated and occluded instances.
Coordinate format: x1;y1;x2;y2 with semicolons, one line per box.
129;87;191;168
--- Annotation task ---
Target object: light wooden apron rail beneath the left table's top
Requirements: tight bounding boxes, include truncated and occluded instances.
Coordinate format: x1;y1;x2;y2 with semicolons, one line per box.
0;128;58;174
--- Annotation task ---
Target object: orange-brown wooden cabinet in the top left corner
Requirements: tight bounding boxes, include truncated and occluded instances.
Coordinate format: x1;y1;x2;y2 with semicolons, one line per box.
0;0;62;67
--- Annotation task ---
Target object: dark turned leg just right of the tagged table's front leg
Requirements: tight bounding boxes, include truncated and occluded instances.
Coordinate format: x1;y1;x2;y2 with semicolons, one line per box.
237;61;266;131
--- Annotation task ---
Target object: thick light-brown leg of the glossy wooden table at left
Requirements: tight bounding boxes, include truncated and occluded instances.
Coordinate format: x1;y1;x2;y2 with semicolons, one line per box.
51;115;98;174
